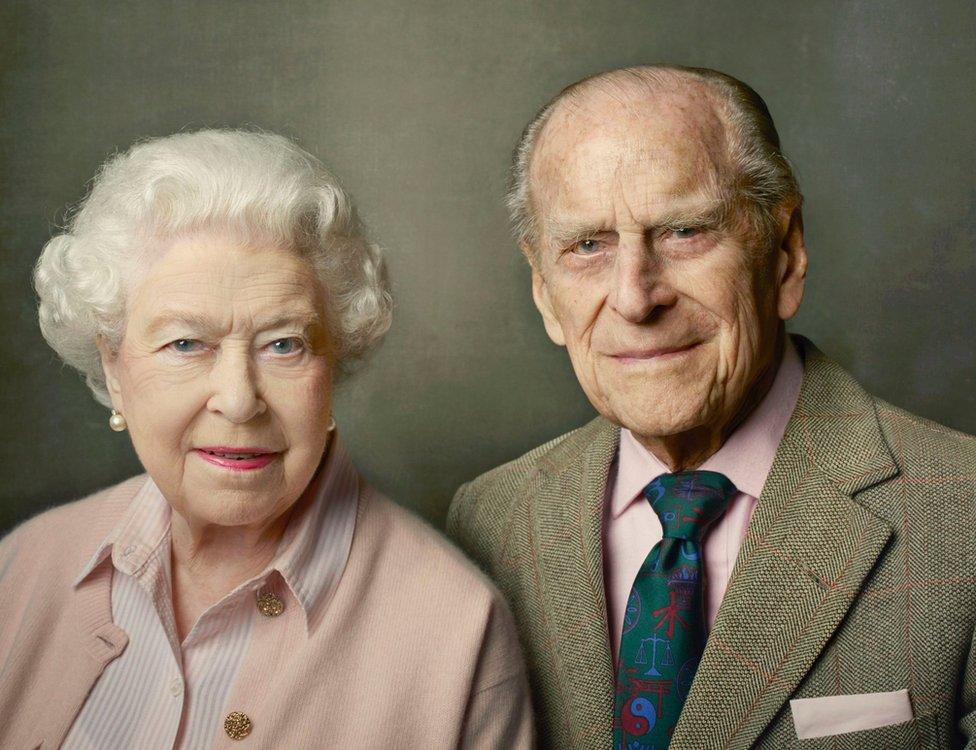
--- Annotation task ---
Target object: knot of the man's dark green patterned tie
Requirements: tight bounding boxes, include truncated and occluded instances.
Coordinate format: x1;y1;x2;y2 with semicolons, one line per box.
643;471;737;542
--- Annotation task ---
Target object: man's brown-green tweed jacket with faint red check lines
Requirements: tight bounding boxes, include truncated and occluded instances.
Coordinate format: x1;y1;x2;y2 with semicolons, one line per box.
448;337;976;750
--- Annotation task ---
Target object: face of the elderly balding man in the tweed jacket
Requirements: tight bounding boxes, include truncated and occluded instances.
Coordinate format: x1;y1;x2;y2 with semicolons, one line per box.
529;93;805;438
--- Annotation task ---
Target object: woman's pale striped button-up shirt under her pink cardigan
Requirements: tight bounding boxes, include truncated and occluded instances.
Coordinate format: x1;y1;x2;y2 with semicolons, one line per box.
62;433;359;750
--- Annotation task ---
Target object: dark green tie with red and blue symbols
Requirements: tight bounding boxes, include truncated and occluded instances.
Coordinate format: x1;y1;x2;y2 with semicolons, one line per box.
613;471;737;750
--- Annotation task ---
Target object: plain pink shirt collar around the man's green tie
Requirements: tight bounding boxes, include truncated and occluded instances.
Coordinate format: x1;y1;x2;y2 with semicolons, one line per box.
610;336;803;518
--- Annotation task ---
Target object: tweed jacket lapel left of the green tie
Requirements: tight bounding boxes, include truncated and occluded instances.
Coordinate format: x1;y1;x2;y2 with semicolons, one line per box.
519;419;620;748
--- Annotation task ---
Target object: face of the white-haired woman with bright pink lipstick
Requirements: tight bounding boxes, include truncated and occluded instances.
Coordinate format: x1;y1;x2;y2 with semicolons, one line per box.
101;234;334;527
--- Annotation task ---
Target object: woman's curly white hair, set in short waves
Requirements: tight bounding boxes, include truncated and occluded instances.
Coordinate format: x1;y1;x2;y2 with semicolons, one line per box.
34;130;392;406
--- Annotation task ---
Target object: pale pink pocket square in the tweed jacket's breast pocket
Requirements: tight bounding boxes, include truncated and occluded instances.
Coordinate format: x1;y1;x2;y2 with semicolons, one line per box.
790;690;913;740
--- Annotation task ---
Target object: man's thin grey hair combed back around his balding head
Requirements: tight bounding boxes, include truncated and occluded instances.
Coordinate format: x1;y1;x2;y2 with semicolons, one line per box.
507;65;803;259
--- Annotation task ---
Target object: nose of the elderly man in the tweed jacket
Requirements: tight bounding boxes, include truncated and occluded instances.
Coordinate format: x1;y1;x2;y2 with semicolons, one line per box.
608;238;677;323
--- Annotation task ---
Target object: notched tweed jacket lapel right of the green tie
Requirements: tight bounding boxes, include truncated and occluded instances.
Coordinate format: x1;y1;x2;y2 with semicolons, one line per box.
671;339;897;748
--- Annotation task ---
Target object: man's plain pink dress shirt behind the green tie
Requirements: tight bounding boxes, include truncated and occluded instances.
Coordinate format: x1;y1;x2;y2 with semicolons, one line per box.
603;337;803;656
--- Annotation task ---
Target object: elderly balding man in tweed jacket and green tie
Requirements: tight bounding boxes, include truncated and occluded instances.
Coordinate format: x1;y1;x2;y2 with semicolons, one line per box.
448;66;976;750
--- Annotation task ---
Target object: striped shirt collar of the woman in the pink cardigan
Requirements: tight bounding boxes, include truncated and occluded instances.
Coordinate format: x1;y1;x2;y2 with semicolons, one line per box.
74;431;360;632
